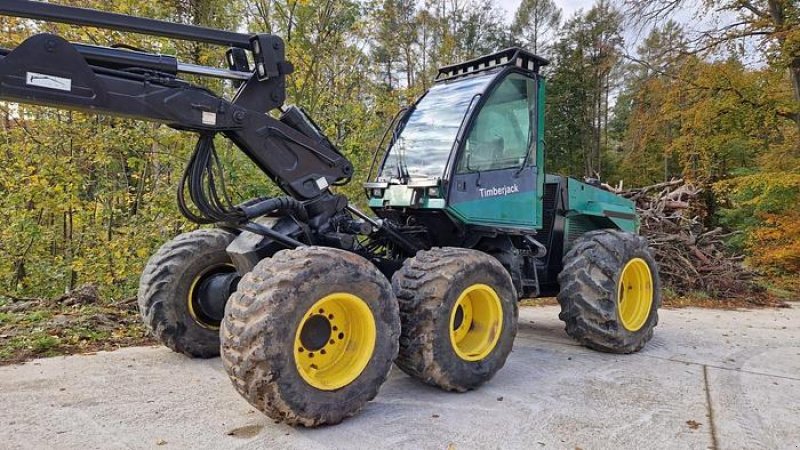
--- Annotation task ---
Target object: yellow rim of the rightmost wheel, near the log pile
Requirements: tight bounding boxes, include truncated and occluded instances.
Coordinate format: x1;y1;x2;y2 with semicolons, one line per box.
617;258;653;331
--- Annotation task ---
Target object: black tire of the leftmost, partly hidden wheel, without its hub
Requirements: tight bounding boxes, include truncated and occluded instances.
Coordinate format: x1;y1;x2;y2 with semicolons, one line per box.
138;229;236;358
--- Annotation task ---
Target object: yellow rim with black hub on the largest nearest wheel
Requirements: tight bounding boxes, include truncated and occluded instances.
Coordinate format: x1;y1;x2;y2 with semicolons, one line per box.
294;293;377;391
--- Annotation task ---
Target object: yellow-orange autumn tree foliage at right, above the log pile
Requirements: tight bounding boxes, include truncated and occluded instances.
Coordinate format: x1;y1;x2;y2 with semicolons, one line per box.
617;0;800;274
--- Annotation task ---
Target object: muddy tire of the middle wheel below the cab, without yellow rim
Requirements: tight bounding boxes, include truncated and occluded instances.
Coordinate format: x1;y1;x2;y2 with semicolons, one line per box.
392;248;518;392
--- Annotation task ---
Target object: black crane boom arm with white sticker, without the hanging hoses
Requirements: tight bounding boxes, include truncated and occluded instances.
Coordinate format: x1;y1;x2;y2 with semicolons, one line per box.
0;0;352;204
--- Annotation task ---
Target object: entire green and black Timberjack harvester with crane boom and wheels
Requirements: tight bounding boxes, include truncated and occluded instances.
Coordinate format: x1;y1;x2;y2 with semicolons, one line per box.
0;0;661;426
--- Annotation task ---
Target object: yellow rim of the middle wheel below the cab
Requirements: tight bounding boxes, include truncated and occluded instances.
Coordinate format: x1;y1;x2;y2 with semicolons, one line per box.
450;284;503;361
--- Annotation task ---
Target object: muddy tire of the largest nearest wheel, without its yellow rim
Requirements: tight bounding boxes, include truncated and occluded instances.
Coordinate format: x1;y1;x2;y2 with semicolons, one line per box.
220;247;400;427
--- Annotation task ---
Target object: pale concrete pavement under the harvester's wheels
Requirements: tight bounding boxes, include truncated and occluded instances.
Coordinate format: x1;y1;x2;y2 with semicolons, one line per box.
0;305;800;449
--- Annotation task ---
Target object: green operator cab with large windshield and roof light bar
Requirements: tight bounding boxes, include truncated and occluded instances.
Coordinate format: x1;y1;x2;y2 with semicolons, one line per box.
366;48;548;242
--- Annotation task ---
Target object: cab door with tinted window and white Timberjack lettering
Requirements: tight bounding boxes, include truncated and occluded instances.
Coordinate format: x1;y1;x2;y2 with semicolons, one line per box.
448;72;541;228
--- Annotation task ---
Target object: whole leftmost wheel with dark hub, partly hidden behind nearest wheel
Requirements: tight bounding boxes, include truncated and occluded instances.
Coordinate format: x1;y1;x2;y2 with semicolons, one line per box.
139;229;239;358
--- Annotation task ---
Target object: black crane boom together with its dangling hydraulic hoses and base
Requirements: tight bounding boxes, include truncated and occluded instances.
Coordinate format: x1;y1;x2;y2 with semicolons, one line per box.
0;0;384;253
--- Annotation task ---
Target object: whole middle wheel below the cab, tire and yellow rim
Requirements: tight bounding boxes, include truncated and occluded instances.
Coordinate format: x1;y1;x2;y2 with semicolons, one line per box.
392;248;518;392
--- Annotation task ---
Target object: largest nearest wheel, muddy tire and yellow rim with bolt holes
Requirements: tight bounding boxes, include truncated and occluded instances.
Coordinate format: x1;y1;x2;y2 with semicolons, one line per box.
220;247;400;427
